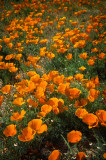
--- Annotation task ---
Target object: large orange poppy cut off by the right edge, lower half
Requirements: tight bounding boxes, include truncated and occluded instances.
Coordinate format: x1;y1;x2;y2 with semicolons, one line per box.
96;110;106;127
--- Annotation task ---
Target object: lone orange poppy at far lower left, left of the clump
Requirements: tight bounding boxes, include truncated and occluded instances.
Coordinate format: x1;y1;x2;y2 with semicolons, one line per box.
3;124;17;137
